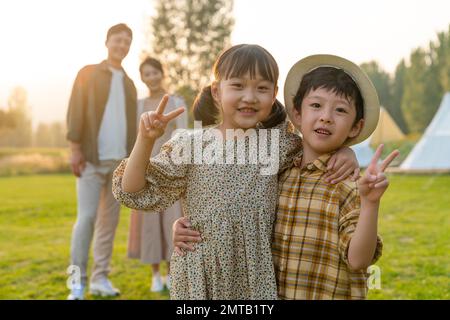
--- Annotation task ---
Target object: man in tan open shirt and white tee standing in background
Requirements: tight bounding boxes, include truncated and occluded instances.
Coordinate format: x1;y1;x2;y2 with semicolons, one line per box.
67;24;137;300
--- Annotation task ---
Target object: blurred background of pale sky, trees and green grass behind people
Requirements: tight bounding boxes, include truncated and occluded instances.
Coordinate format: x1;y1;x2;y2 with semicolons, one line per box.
0;0;450;299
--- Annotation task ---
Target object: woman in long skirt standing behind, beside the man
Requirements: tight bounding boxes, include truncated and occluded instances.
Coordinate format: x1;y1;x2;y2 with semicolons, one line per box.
128;57;187;292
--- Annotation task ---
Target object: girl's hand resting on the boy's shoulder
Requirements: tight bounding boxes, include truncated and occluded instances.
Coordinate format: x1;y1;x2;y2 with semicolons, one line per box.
324;147;360;184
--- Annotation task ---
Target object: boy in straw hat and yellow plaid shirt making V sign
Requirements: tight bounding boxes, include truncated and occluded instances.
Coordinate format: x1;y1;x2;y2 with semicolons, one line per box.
272;55;398;299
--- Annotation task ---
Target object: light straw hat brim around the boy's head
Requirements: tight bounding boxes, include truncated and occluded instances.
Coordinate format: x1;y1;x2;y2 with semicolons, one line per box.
284;54;380;146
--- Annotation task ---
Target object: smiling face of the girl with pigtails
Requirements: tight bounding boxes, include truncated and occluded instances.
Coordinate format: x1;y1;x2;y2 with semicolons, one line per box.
212;72;278;129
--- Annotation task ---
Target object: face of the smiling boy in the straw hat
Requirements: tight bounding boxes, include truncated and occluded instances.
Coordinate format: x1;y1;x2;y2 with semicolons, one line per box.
293;88;364;157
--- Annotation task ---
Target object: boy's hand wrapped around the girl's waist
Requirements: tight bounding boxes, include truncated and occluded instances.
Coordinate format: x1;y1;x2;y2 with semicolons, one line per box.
172;217;202;256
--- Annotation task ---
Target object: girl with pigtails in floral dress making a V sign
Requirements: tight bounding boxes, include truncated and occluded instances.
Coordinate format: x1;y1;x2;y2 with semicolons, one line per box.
113;44;357;299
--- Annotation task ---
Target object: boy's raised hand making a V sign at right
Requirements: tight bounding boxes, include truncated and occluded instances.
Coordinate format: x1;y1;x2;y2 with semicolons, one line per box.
359;144;400;202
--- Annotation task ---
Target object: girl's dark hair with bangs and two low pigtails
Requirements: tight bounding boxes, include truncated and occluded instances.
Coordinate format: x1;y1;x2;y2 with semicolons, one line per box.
193;44;286;128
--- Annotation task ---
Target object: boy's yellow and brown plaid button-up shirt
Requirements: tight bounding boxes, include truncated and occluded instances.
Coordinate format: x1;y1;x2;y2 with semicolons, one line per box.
272;154;382;299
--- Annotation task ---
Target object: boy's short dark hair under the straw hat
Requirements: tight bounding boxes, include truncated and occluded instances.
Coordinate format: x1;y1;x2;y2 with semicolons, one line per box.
293;67;364;124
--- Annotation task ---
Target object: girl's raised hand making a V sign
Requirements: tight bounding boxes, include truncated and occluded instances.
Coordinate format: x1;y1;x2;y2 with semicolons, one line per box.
139;94;184;140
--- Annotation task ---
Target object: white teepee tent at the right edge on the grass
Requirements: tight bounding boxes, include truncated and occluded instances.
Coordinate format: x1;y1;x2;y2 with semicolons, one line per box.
400;92;450;170
